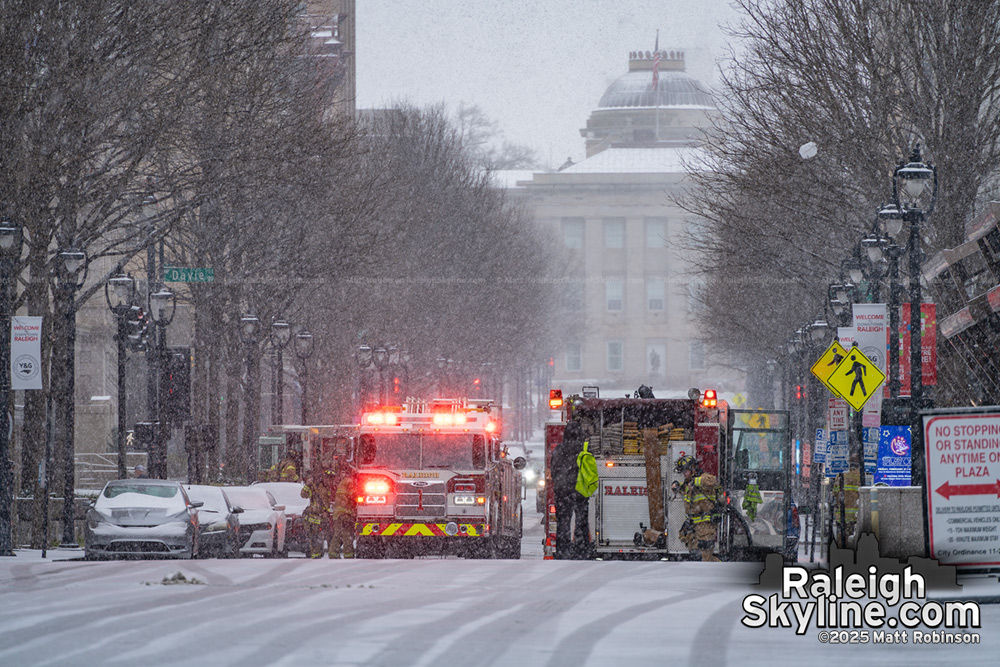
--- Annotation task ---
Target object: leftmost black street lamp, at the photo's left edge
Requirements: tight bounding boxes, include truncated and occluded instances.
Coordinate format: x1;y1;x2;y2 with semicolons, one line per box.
0;220;24;556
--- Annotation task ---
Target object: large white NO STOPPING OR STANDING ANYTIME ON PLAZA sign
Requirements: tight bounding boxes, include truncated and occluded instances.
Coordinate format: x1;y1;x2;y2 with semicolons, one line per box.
924;408;1000;567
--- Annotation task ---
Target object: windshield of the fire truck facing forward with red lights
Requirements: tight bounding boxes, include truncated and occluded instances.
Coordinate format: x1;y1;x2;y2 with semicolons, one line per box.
361;433;486;470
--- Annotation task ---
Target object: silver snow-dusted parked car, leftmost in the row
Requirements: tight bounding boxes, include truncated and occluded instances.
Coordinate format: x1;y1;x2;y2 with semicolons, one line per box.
84;479;202;560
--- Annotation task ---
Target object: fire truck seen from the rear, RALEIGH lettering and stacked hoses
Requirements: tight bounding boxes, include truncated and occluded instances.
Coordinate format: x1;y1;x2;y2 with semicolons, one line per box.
544;388;797;560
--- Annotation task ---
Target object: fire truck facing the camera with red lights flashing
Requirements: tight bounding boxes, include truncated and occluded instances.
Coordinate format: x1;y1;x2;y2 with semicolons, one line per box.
355;399;526;558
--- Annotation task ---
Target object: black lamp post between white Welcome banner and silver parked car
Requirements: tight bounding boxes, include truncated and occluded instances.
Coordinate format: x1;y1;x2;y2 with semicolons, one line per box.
50;248;87;547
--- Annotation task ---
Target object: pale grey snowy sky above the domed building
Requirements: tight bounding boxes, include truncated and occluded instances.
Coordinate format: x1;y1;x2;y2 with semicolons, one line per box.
357;0;739;166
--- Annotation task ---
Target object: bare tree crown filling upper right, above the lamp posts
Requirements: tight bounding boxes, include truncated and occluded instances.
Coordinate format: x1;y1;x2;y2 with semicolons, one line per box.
682;0;1000;380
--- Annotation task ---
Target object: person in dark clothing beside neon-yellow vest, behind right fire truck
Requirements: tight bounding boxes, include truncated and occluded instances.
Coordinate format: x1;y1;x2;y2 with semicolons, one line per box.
552;421;591;559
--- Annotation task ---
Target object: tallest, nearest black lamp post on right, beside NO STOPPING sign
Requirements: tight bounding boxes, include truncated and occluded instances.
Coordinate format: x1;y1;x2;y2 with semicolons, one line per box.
892;144;937;496
